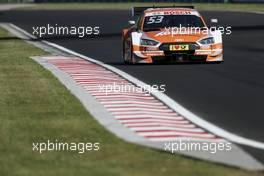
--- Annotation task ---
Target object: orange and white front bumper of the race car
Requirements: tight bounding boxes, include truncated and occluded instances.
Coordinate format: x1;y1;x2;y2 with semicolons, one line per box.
133;43;223;63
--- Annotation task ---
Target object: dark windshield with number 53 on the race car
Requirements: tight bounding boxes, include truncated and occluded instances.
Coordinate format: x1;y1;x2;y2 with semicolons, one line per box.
143;15;205;30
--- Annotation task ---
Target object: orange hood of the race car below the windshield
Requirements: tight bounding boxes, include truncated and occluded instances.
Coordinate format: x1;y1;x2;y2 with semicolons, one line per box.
143;29;208;43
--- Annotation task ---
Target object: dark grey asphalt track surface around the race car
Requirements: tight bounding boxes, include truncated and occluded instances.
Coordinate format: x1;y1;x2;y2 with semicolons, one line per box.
0;10;264;163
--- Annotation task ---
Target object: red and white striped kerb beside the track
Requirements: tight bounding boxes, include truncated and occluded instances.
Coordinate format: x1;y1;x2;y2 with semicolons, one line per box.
44;56;220;141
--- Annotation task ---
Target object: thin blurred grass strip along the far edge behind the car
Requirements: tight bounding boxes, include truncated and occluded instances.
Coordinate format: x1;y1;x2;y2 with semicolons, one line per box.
17;3;264;11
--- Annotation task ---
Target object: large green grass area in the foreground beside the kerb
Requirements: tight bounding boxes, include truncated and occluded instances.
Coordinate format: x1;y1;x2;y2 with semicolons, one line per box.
0;29;263;176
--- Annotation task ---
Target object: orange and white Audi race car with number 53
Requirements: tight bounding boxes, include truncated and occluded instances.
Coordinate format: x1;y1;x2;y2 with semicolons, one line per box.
122;6;223;64
